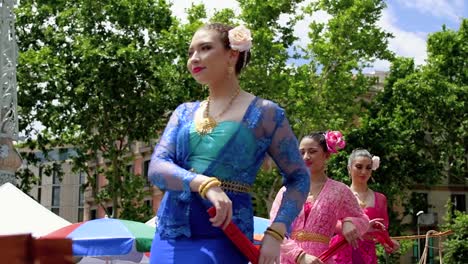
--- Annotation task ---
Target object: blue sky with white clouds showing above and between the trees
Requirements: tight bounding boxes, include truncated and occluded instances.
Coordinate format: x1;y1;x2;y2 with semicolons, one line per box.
170;0;468;70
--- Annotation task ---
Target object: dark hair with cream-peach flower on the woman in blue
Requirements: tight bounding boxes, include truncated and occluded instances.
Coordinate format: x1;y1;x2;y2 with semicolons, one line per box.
200;23;252;74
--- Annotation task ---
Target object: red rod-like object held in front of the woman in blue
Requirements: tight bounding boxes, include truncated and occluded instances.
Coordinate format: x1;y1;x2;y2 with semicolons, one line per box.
208;207;260;264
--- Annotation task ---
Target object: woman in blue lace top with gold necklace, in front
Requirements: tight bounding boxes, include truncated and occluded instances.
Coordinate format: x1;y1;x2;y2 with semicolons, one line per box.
149;23;309;264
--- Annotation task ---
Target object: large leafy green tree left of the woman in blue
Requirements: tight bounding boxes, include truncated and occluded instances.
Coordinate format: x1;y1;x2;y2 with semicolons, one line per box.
16;0;179;220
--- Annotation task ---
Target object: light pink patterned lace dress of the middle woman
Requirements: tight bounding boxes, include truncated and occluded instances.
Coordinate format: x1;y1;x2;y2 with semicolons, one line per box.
270;179;369;264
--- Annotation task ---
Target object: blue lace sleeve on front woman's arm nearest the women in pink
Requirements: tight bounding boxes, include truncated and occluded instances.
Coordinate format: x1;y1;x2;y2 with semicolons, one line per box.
264;105;310;233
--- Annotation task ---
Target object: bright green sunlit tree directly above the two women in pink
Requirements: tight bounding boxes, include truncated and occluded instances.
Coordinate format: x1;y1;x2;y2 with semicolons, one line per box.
285;0;393;134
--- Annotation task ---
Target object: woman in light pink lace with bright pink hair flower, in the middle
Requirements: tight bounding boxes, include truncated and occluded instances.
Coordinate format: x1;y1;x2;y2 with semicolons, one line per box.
270;131;369;264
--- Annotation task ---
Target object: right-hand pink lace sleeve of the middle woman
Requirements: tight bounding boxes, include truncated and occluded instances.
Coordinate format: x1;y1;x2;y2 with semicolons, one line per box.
339;187;369;236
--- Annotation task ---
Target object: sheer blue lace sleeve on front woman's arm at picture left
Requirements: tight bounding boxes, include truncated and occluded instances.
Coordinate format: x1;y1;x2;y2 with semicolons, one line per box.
148;104;197;197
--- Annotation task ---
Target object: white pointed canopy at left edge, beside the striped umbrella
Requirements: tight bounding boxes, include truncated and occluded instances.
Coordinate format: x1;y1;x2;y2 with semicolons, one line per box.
0;182;70;237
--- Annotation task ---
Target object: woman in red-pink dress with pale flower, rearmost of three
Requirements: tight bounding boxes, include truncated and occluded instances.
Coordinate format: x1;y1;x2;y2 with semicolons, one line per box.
334;149;400;264
